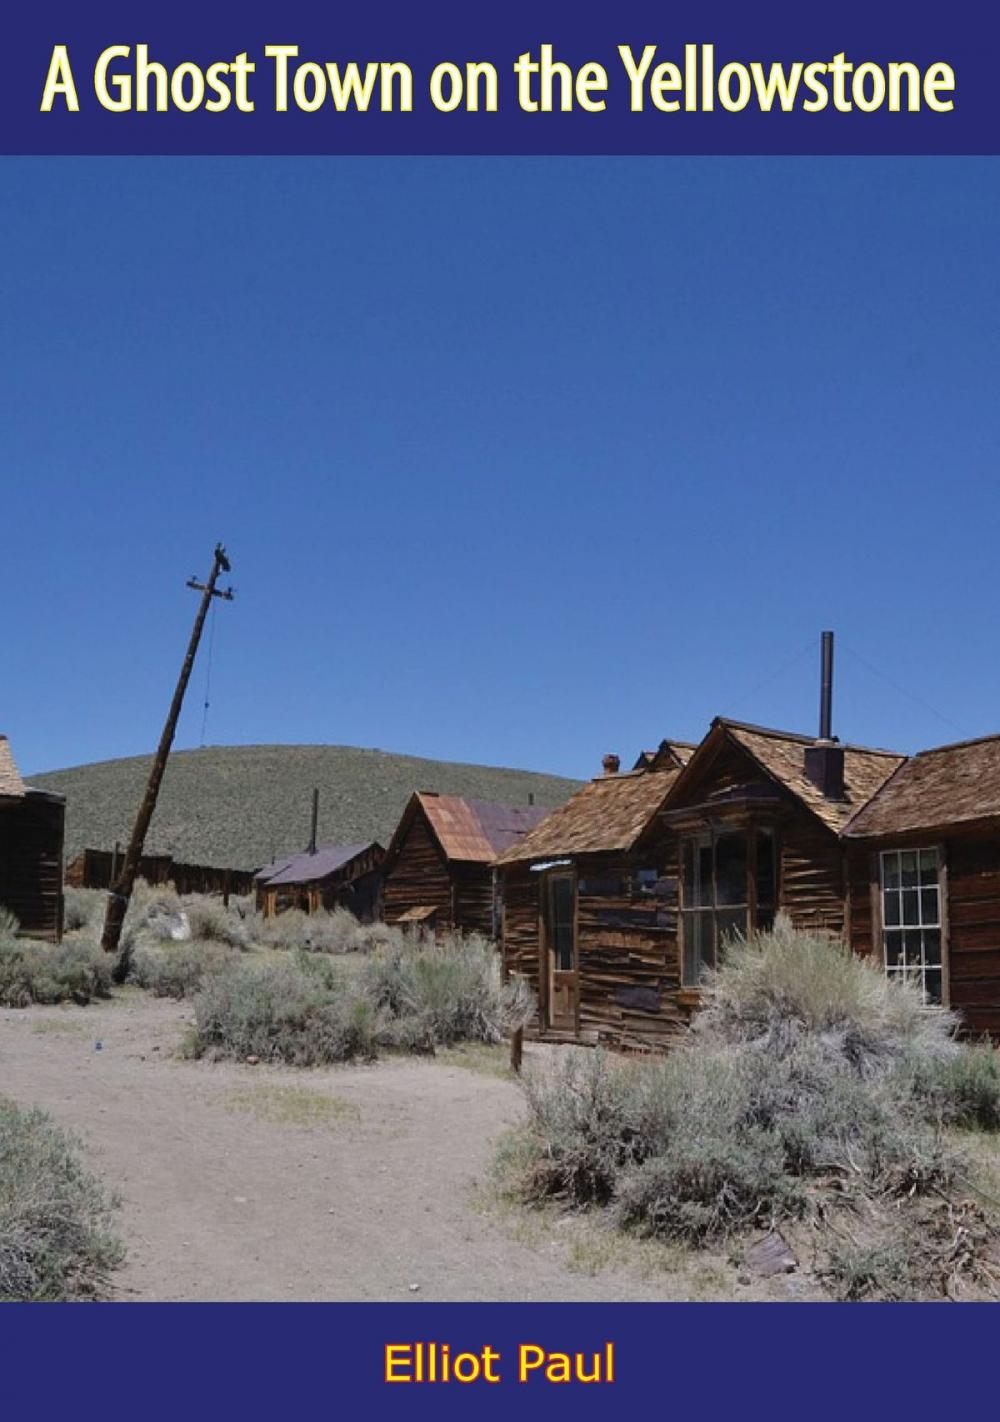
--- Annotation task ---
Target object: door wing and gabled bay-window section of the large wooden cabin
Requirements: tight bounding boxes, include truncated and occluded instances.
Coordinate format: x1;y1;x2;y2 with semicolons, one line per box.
499;718;903;1048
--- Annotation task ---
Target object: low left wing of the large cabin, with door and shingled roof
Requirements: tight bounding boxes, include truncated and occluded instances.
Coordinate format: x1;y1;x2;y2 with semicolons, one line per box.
496;741;694;1047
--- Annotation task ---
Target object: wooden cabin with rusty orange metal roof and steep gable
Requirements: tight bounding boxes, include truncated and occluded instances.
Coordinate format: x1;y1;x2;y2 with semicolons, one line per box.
383;791;548;937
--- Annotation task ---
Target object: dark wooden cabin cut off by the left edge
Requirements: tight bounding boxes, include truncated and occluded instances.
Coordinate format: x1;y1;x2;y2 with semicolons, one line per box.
0;735;65;943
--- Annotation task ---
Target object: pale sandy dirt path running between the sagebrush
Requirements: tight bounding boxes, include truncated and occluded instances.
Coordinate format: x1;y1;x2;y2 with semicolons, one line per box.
0;994;697;1301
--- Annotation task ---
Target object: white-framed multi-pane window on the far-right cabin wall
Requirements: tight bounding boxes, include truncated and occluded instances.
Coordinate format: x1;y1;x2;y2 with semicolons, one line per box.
881;849;943;1003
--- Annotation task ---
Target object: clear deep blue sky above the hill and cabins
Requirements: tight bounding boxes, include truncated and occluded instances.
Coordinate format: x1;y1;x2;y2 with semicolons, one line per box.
0;158;1000;775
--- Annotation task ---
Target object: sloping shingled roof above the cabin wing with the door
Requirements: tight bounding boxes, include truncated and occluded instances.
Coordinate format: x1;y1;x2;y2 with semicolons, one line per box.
498;768;680;865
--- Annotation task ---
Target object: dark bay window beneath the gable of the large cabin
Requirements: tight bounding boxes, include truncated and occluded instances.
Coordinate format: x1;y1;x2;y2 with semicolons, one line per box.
681;829;777;987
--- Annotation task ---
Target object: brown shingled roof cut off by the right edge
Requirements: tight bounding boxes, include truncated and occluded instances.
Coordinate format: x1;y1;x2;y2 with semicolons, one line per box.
844;735;1000;839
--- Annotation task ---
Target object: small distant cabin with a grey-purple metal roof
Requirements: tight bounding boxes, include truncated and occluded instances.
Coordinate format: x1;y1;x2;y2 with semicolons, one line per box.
255;840;385;923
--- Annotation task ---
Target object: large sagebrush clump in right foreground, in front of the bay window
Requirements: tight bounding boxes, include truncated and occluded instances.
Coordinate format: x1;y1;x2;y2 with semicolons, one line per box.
499;923;1000;1297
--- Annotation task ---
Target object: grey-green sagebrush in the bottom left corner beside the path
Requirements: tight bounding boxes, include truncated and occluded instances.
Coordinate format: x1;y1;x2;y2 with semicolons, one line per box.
0;1096;124;1303
